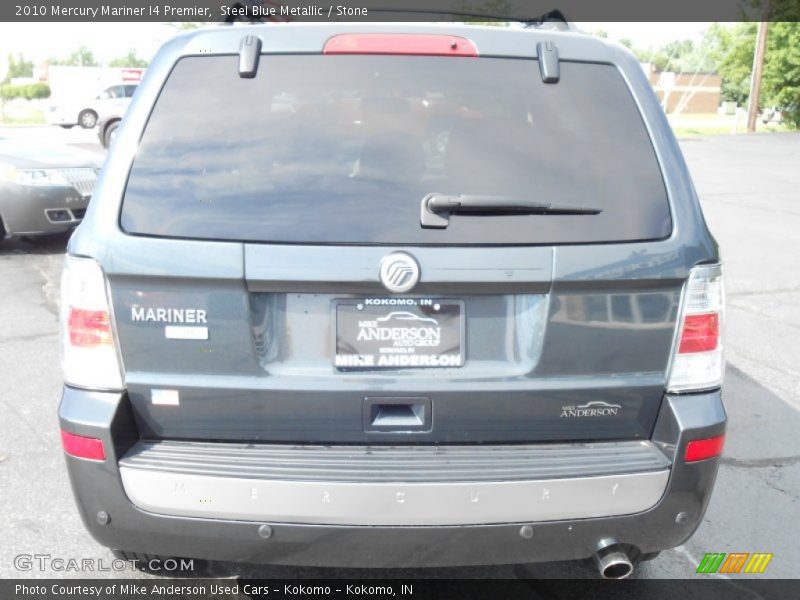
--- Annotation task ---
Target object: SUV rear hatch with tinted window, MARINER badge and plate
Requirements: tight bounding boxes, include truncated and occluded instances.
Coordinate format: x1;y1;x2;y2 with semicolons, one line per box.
109;36;683;443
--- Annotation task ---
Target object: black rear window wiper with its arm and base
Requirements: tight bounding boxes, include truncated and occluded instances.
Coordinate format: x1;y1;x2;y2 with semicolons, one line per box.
420;194;603;229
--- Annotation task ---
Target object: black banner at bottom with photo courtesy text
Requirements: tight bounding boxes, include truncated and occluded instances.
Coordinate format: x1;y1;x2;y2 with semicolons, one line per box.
0;578;800;600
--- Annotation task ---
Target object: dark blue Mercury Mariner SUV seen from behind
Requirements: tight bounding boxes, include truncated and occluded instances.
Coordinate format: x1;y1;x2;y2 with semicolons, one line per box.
60;24;726;577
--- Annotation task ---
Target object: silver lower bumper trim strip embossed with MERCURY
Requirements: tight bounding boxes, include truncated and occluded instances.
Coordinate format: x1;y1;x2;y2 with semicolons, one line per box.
120;466;669;526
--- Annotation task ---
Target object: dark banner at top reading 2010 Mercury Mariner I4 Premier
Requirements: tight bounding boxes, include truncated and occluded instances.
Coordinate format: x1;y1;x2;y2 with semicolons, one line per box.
0;0;800;23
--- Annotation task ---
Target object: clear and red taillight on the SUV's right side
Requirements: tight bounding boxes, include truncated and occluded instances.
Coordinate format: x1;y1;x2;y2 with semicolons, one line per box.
667;264;725;392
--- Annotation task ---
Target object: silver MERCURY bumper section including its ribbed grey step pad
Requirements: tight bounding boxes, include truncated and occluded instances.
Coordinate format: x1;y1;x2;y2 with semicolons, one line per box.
119;442;670;527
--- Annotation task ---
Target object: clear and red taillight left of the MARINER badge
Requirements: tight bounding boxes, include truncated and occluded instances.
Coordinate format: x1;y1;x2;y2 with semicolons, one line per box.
61;256;122;390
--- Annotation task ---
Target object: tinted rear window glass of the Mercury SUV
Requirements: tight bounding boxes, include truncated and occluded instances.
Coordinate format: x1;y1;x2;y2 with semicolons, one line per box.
121;55;671;245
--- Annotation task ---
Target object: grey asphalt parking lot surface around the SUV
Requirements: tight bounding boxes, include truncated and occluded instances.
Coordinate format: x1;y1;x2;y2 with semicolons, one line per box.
0;127;800;578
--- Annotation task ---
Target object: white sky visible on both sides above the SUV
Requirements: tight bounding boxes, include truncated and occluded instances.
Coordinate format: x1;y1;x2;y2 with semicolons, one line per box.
0;22;709;63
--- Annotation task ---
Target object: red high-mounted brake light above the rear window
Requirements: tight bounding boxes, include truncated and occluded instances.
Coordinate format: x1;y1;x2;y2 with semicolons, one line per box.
322;33;478;56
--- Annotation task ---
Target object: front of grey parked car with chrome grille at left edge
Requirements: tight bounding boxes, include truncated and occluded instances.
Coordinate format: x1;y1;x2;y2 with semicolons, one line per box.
0;138;100;240
